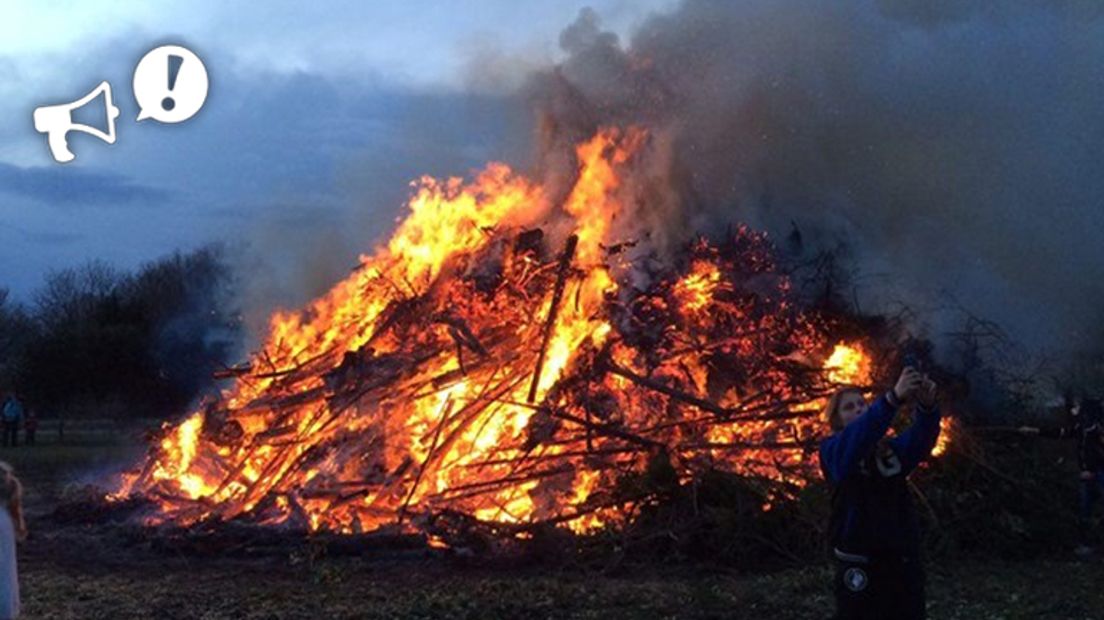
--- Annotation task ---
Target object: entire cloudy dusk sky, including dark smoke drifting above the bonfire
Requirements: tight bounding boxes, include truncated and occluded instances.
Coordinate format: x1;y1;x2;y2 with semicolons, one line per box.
0;0;1104;349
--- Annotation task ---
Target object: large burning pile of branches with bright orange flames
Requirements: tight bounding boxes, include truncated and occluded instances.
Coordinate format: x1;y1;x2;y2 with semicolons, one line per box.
112;129;896;534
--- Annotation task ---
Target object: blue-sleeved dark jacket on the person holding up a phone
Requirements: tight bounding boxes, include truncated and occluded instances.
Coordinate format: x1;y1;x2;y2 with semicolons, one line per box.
820;394;940;556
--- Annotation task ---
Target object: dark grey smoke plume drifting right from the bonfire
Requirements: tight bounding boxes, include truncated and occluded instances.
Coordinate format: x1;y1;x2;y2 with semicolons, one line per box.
526;0;1104;351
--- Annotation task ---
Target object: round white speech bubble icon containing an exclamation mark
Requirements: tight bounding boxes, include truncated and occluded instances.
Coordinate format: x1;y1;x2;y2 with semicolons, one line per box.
134;45;209;122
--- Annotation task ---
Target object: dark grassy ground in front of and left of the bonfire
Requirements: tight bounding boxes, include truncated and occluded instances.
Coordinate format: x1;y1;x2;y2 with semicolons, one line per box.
0;432;1104;620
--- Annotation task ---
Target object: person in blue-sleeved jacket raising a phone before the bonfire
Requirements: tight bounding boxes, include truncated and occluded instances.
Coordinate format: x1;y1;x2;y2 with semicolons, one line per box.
820;367;940;620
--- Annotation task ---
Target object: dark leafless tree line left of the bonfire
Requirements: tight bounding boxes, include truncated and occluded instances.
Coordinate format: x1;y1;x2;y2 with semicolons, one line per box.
0;246;242;418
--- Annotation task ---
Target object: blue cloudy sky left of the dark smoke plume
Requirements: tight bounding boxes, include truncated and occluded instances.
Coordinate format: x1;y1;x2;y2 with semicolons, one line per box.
0;0;675;299
